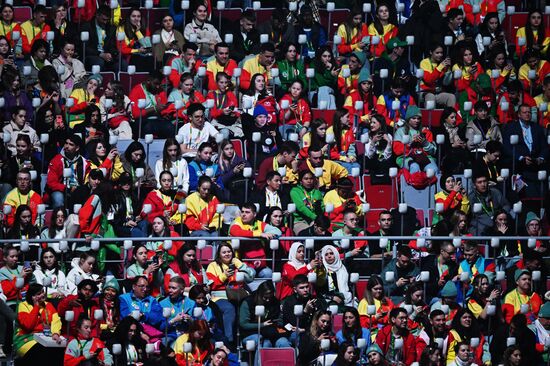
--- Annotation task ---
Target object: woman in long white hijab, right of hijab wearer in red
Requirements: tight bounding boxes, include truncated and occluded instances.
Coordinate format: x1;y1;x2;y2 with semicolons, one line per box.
317;245;354;307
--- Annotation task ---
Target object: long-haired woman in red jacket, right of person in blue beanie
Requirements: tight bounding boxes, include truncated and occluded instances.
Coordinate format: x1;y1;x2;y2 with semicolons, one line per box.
279;80;311;140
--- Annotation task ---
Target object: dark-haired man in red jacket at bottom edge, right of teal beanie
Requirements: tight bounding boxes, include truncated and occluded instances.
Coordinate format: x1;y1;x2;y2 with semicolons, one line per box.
376;308;417;365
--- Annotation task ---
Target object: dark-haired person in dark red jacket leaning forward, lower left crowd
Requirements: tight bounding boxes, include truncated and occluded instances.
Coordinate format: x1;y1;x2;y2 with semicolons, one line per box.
57;279;100;337
